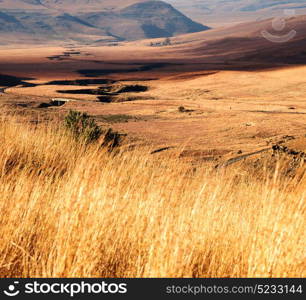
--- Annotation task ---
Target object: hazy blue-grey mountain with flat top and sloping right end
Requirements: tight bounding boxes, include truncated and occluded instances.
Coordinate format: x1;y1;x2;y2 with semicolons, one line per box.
0;0;209;43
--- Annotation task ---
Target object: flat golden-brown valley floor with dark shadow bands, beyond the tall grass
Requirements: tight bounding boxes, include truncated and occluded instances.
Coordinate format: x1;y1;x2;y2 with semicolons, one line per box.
0;47;306;163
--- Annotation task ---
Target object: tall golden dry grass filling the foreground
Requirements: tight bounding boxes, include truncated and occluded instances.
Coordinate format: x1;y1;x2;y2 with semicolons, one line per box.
0;119;306;277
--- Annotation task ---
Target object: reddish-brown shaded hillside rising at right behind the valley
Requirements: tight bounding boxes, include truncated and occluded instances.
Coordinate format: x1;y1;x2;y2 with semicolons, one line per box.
166;15;306;68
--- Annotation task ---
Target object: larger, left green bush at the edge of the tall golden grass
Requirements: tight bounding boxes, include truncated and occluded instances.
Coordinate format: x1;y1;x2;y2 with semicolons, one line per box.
64;110;103;144
